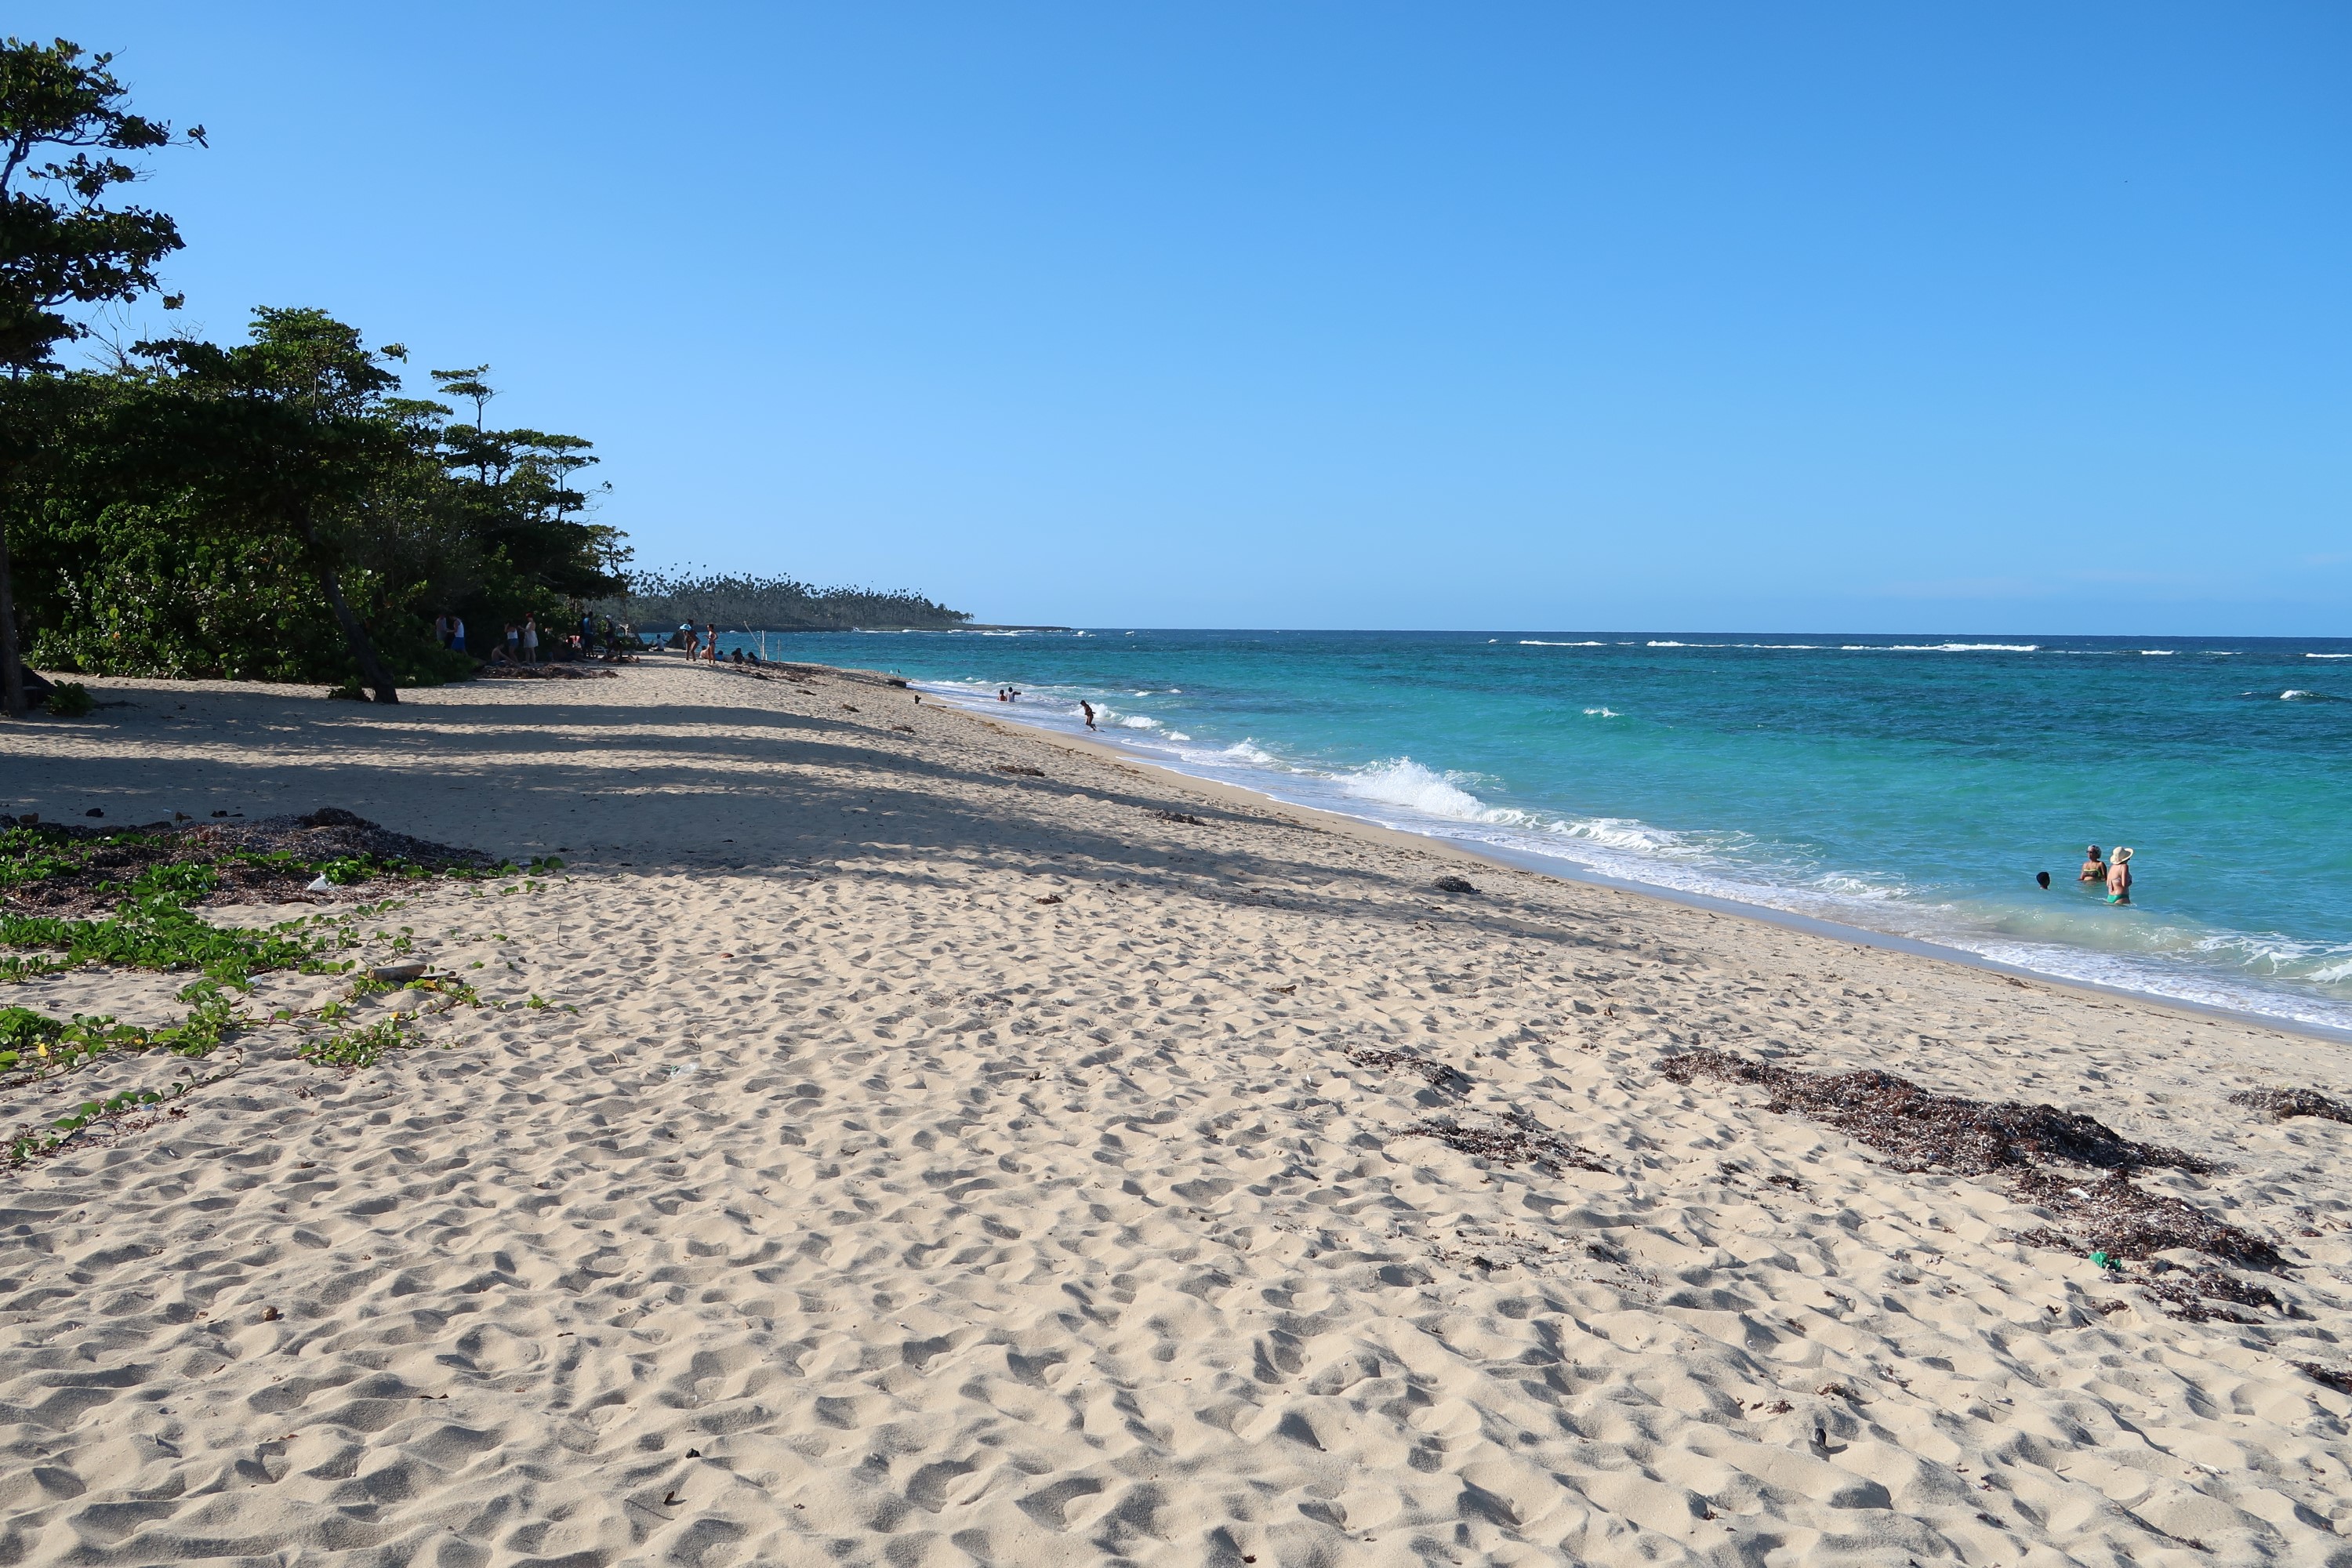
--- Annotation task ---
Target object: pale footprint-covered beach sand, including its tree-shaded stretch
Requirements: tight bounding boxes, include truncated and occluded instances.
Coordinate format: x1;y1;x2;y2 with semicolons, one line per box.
0;663;2352;1568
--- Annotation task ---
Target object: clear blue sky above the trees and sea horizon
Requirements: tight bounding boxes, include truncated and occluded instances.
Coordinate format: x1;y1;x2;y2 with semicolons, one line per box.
23;2;2352;635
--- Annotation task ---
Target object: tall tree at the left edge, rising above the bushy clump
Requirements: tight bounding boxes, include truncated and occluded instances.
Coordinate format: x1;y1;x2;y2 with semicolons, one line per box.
0;38;205;717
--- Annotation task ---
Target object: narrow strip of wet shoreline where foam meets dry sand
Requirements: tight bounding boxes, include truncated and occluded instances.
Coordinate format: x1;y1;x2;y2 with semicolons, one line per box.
908;681;2352;1044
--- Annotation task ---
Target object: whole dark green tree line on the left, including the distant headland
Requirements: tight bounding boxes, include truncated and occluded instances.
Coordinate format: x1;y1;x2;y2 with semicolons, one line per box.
0;38;967;715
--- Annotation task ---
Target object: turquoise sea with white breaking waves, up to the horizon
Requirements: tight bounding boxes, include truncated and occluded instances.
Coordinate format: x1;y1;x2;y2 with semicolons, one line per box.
741;628;2352;1027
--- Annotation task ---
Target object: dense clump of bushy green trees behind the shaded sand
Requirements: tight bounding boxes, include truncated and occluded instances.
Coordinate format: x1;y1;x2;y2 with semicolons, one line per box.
12;310;623;687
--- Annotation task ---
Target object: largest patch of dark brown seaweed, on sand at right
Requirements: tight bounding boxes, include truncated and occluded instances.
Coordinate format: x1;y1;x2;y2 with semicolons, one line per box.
1658;1051;2284;1269
